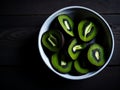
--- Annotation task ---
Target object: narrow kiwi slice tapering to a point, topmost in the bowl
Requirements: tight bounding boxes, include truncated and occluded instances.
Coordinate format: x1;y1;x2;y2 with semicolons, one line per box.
58;14;74;36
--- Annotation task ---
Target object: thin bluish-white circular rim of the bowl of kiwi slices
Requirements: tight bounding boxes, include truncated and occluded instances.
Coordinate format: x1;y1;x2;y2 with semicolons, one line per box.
38;6;115;80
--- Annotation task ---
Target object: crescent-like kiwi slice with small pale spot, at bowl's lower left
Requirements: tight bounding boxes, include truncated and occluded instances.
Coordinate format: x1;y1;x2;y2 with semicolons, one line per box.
51;53;72;73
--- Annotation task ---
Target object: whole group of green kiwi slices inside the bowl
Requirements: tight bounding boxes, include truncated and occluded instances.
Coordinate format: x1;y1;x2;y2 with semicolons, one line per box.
42;14;105;75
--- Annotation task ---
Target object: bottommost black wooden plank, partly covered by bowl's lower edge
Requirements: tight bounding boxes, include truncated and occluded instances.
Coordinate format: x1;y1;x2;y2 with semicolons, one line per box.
0;66;120;90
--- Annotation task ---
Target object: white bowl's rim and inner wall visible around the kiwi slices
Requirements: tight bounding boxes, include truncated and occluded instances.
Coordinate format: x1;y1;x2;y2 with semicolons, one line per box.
38;7;114;79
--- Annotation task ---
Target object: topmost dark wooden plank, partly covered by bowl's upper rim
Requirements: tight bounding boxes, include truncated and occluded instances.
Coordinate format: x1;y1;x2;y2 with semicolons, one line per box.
0;0;120;15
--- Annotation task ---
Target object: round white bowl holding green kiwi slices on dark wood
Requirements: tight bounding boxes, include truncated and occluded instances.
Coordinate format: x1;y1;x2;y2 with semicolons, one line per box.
38;6;114;80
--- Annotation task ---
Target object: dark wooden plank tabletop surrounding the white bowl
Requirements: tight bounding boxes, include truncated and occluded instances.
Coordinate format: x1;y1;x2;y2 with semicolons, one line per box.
0;0;120;90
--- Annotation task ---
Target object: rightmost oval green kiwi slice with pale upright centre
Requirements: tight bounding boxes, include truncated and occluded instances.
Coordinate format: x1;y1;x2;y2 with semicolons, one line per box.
87;43;105;66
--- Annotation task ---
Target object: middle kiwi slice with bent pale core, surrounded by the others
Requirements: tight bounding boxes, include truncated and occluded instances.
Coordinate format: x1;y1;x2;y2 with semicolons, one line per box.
68;39;86;60
